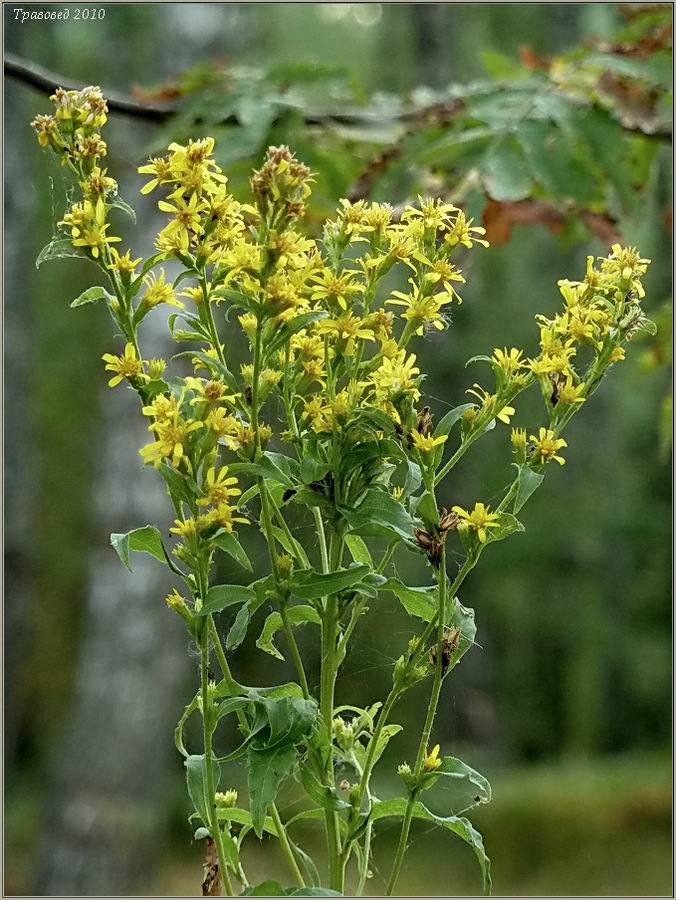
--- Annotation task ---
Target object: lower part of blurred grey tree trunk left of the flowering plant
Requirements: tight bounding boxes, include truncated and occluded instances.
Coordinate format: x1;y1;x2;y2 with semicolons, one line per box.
35;362;187;896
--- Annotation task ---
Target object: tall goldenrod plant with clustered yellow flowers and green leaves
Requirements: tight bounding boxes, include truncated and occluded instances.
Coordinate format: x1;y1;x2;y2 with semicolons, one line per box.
33;87;652;896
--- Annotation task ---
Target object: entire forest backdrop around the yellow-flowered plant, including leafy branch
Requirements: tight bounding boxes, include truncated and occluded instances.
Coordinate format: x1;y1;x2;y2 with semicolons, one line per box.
4;3;672;896
